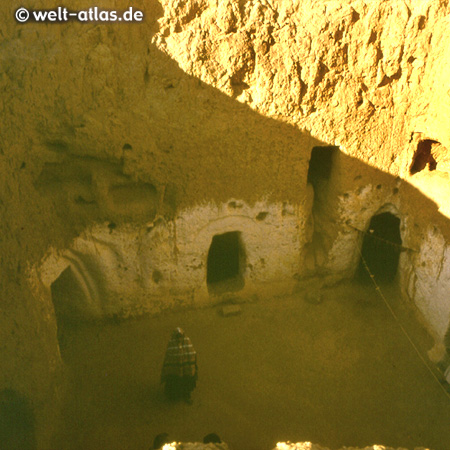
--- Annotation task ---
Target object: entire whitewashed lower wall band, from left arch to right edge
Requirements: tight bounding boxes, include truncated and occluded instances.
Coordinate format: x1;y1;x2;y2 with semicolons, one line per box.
36;192;450;354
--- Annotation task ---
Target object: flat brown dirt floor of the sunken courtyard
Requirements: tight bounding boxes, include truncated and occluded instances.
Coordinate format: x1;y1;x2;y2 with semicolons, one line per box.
56;283;450;450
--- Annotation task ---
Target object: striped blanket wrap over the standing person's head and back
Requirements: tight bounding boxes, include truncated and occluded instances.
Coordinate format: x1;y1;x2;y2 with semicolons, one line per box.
161;333;197;380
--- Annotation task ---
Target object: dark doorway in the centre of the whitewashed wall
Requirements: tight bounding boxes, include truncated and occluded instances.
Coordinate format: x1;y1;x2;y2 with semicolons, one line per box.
206;231;245;293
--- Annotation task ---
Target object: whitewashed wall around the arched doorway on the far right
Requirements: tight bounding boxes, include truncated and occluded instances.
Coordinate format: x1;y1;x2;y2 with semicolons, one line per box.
325;185;450;360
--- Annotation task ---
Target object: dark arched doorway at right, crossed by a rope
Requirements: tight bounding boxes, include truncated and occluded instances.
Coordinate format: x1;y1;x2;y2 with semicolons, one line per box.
357;212;402;283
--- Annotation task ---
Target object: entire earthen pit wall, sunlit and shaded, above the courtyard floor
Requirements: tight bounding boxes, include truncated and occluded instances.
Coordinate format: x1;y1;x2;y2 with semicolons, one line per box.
0;0;450;448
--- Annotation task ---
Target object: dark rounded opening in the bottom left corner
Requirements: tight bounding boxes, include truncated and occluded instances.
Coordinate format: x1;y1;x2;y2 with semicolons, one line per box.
0;389;36;450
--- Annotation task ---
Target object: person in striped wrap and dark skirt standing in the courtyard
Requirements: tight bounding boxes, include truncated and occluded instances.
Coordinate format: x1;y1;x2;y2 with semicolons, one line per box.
161;328;198;404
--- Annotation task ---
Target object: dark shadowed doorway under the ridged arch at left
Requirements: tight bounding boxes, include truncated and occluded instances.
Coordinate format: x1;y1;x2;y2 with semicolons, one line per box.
51;266;86;357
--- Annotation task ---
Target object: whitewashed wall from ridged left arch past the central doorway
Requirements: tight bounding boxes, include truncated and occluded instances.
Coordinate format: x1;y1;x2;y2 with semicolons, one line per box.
38;200;311;317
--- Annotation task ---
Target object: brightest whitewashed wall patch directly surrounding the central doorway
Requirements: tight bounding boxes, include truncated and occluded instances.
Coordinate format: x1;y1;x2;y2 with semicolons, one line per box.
172;200;310;301
